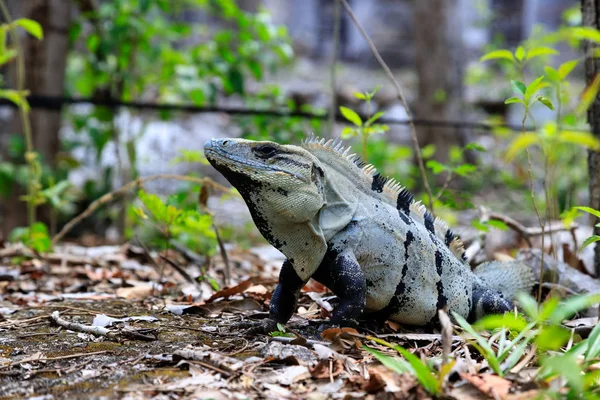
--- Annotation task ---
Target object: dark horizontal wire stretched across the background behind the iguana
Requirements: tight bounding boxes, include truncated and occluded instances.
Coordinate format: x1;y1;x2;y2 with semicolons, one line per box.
0;95;564;132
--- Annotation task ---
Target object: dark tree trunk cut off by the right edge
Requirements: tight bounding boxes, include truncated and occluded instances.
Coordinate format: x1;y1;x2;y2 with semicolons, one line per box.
581;0;600;276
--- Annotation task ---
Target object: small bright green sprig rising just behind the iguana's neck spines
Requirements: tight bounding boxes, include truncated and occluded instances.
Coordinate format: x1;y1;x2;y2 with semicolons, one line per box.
340;86;390;162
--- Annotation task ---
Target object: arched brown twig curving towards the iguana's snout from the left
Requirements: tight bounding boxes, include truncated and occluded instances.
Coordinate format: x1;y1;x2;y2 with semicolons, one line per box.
52;174;229;245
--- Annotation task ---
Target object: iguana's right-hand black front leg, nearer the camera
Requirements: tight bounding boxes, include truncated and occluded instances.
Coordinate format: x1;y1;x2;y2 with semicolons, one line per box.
313;249;367;327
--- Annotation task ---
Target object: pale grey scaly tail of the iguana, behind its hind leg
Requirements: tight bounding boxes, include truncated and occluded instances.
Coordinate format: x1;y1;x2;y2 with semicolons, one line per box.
473;261;536;301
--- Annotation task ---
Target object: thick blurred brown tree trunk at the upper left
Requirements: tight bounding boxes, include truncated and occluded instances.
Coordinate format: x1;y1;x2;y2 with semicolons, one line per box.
0;0;71;235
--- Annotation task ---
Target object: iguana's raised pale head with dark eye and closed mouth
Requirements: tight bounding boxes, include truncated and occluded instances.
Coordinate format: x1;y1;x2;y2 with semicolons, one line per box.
204;138;325;223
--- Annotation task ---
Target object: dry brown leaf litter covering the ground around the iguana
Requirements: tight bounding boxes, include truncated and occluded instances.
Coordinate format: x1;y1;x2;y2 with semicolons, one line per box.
0;227;598;399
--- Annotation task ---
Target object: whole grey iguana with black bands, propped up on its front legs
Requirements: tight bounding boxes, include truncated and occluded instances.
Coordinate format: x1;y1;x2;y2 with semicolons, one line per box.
204;135;533;330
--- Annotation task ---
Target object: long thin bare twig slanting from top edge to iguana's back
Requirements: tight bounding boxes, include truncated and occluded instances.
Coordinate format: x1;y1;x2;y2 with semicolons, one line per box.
340;0;434;213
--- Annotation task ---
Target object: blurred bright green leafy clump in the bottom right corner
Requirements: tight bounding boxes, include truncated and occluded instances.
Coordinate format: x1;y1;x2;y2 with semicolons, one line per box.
453;294;600;397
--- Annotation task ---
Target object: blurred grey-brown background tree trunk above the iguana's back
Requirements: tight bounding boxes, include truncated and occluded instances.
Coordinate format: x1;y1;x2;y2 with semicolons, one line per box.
413;0;465;170
